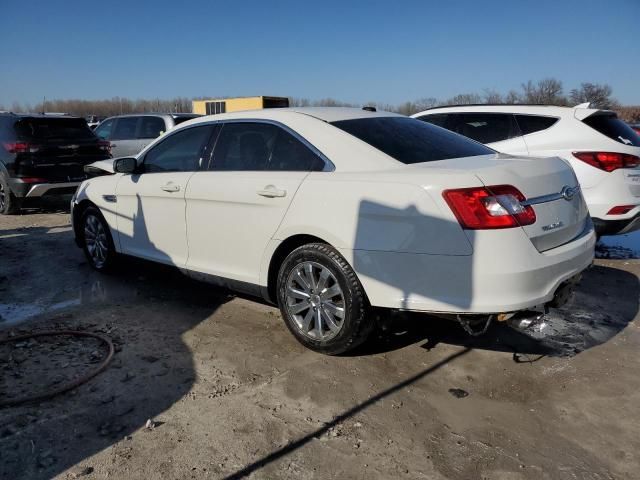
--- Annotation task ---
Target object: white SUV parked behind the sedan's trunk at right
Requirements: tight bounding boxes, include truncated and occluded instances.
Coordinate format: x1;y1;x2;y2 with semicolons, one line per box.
413;104;640;235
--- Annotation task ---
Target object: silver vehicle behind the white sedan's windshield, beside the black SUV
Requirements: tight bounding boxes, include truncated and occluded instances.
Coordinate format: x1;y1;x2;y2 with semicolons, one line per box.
94;113;200;158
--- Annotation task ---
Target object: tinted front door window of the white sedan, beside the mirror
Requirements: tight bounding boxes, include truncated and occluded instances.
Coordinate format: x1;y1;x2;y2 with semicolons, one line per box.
144;125;213;173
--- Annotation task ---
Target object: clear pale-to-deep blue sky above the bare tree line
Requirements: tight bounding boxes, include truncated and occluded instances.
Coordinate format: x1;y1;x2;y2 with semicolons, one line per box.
0;0;640;107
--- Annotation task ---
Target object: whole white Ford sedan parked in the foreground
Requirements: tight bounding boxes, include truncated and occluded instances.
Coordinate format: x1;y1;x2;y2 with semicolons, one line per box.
72;108;595;354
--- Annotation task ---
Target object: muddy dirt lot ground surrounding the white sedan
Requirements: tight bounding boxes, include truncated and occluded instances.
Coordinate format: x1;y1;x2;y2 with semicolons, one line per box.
0;200;640;480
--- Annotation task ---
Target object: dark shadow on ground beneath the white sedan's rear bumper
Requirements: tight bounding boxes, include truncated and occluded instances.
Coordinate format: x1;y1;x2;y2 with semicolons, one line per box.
351;266;640;362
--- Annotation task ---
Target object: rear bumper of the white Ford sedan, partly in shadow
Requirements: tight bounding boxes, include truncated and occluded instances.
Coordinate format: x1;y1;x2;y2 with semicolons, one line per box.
341;223;596;314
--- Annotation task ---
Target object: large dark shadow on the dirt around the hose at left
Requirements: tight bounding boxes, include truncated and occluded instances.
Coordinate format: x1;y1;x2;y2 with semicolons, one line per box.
0;229;233;479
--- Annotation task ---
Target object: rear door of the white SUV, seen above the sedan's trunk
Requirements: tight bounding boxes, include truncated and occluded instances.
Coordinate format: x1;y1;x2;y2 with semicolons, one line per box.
447;112;528;155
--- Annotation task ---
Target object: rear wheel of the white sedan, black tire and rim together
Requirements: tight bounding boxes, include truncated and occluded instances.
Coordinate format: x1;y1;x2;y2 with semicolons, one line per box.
277;243;374;355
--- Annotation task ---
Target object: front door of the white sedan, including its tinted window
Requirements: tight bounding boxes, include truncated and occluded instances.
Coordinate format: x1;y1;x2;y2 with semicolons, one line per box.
116;125;213;266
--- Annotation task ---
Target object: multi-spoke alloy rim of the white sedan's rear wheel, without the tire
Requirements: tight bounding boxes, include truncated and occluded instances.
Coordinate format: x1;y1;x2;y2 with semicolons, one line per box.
286;261;345;341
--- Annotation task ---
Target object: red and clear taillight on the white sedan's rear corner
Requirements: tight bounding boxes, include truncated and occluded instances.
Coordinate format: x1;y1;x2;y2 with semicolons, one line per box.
442;185;536;230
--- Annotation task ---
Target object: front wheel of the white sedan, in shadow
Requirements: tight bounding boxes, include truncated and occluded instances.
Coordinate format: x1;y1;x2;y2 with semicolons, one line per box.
81;207;117;272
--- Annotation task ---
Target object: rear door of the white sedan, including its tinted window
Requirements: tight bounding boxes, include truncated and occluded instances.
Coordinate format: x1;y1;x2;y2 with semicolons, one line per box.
186;122;325;284
